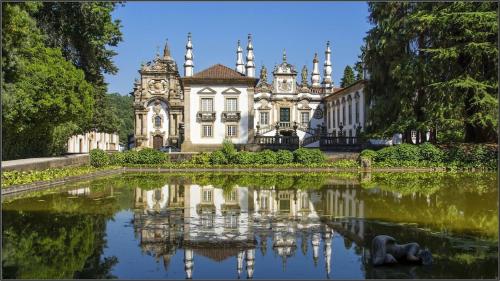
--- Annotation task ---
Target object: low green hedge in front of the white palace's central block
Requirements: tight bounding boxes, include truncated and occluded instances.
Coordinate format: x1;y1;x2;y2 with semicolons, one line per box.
190;142;326;165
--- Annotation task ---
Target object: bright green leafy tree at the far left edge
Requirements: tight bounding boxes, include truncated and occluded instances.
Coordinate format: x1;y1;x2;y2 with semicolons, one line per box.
2;2;94;160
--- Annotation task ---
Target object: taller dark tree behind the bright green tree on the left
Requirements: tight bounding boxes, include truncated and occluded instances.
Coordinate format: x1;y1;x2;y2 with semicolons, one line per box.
35;2;122;132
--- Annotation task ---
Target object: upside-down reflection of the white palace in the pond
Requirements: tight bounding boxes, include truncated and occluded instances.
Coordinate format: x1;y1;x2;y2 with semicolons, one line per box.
134;184;364;278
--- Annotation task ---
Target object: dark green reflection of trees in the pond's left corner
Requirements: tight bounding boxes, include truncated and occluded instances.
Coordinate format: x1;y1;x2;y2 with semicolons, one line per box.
2;183;117;279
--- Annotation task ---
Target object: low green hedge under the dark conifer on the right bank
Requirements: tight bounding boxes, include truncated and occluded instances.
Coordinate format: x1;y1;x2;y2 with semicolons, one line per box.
360;143;498;169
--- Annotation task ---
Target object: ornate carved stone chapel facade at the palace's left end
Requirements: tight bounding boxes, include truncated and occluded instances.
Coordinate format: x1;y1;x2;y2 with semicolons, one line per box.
131;43;184;149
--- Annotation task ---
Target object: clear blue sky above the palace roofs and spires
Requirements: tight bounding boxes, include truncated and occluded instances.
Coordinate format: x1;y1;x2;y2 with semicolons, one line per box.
106;2;370;95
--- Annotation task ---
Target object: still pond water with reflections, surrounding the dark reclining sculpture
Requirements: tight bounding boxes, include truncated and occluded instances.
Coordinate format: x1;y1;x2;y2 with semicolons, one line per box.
2;173;498;279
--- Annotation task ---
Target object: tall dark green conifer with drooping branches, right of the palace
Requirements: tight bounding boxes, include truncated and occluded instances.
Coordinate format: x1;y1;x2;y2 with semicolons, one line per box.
365;2;498;142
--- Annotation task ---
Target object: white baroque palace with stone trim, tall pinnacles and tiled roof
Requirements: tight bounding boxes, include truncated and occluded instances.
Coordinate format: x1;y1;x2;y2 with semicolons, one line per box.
131;34;366;151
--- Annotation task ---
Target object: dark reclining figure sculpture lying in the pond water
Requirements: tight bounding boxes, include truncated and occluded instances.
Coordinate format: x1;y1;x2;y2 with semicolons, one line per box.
371;235;432;265
